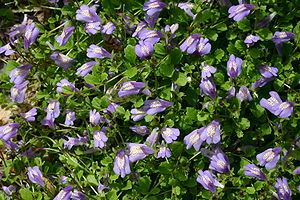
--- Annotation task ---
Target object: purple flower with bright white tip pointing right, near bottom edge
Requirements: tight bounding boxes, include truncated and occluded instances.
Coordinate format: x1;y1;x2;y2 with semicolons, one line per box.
197;170;224;192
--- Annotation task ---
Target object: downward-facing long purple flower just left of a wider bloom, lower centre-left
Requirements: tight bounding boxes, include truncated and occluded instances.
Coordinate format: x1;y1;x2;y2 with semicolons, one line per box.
113;150;131;178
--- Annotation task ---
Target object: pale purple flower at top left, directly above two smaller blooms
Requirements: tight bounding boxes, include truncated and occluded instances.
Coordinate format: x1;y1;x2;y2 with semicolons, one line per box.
76;5;102;23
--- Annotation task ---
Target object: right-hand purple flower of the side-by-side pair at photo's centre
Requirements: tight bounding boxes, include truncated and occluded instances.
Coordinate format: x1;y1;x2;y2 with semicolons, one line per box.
143;99;172;115
